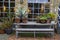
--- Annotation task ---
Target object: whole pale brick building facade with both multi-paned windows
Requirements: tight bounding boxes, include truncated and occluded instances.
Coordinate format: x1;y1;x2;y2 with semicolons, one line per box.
0;0;60;21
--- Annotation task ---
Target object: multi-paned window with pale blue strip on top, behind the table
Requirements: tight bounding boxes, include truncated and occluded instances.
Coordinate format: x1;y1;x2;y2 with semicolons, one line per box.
28;0;50;21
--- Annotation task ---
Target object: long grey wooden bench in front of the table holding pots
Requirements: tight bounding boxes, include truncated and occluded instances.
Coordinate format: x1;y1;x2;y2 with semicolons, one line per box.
16;28;54;37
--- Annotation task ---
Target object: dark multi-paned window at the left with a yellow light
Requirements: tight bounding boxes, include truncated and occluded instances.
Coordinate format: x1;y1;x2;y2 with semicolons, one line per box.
0;0;15;22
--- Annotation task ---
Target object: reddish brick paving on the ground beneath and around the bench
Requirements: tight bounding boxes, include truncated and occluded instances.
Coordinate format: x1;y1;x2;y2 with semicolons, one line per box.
8;35;60;40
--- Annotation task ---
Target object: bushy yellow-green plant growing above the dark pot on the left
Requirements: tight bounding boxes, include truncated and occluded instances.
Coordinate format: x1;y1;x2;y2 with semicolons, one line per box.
0;12;14;29
